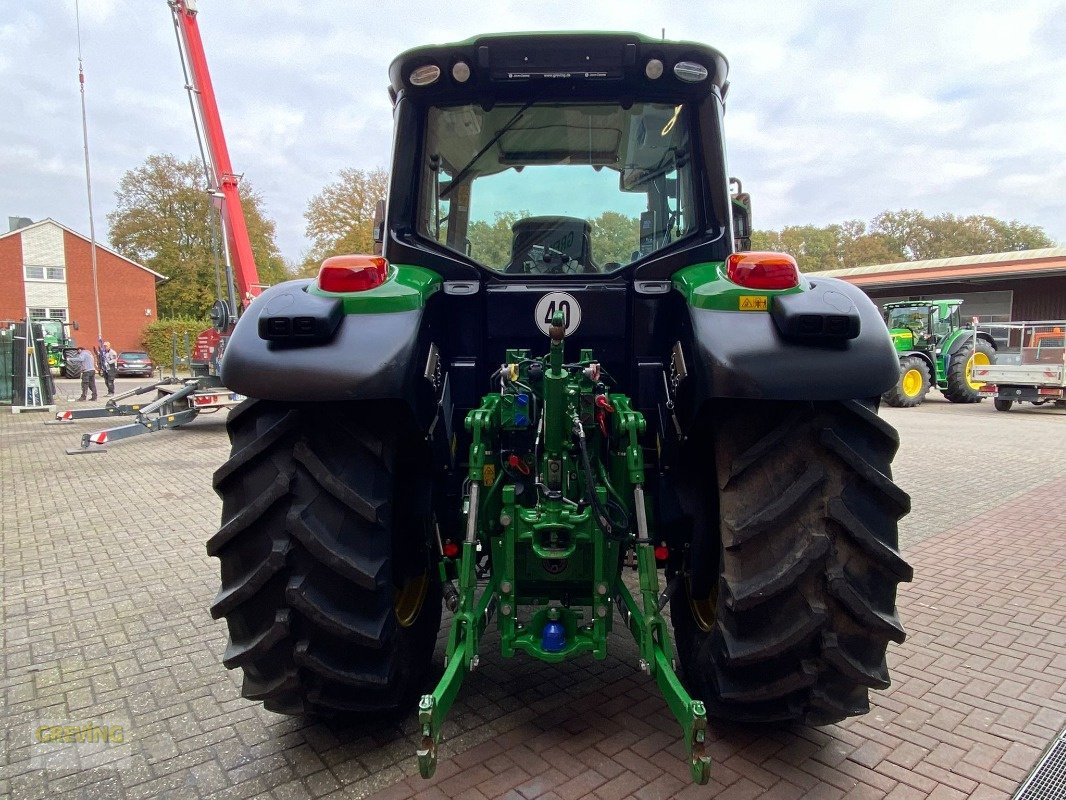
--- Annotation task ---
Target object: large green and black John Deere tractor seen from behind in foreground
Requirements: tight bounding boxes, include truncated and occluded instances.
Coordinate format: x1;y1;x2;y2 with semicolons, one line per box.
208;33;911;782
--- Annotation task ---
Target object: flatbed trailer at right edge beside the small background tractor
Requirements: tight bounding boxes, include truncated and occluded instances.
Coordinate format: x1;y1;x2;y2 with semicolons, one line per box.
971;320;1066;411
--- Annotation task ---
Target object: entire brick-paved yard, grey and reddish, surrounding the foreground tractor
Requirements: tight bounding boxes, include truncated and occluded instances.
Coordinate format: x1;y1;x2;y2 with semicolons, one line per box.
0;382;1066;800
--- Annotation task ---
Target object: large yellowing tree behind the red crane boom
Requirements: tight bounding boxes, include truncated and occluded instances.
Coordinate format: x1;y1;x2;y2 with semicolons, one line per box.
108;154;290;318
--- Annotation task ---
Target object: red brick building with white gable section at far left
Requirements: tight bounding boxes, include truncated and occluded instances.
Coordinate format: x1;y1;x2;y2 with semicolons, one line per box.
0;218;166;350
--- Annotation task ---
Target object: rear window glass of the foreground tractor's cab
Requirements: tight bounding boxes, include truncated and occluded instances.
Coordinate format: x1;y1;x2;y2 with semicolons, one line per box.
419;102;696;275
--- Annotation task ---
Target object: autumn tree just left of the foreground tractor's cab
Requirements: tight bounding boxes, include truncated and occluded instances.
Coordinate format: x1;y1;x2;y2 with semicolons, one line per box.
303;167;389;274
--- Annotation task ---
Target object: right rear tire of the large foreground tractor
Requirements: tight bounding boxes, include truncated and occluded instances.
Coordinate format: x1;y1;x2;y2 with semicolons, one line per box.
671;401;911;724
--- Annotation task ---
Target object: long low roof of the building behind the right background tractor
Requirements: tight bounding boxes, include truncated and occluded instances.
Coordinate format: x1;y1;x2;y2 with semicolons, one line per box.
807;247;1066;288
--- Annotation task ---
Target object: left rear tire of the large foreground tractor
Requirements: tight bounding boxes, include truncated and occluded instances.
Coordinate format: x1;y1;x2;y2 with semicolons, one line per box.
207;400;440;715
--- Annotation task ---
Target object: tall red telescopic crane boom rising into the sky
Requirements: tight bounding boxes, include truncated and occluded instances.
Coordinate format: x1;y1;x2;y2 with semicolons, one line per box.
168;0;262;315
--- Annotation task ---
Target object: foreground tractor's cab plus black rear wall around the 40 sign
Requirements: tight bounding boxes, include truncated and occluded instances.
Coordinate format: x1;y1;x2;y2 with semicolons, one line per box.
383;33;744;407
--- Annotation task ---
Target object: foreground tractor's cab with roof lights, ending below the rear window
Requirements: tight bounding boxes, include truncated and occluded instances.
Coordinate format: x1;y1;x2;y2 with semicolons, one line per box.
384;33;732;283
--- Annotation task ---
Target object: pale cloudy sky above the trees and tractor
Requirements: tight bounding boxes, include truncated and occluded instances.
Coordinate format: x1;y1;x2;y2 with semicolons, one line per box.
0;0;1066;261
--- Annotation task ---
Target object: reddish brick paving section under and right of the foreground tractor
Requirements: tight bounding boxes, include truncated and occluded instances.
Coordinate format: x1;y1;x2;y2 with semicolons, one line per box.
366;479;1066;800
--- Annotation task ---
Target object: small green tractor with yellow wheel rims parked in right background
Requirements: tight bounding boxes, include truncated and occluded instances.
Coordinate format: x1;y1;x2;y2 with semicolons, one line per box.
882;300;996;409
